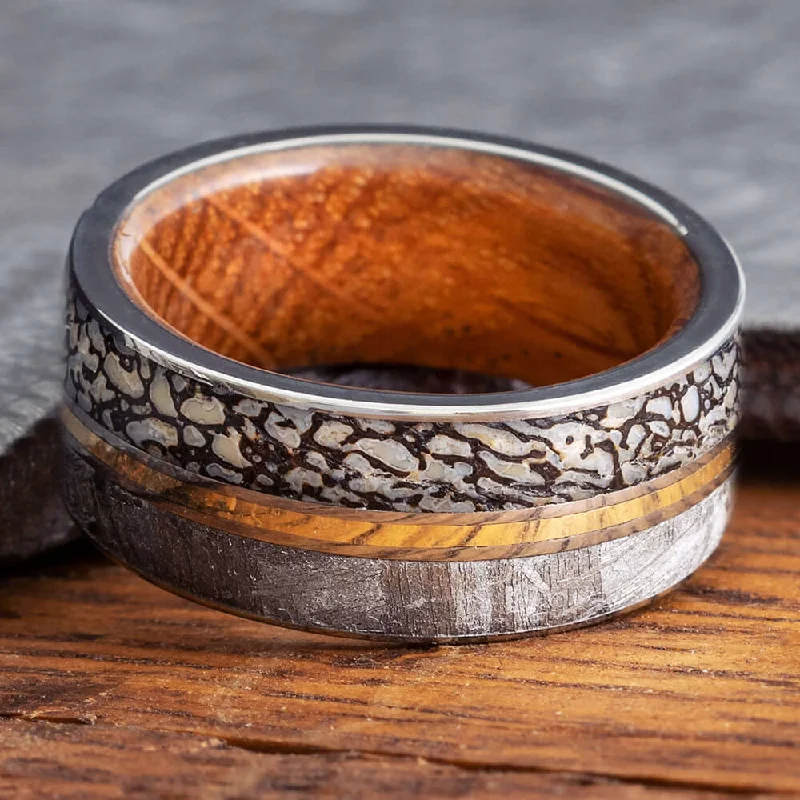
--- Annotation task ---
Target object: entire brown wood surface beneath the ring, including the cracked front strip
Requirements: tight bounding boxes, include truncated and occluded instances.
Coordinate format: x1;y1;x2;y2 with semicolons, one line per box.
0;445;800;799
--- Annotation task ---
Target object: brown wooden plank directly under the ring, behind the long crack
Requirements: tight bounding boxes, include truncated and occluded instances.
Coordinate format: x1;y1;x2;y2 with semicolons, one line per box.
0;450;800;796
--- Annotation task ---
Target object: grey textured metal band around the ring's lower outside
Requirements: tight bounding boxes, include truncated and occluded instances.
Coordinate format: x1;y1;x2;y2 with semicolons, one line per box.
65;434;733;642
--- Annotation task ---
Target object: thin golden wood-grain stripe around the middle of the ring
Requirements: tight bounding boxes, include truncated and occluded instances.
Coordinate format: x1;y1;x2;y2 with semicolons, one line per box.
64;410;733;559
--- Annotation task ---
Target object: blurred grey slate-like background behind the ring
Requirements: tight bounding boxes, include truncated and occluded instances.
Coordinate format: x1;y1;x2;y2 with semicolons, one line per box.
0;0;800;452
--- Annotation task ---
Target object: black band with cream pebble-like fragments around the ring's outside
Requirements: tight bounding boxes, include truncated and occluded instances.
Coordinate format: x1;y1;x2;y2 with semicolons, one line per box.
66;296;739;512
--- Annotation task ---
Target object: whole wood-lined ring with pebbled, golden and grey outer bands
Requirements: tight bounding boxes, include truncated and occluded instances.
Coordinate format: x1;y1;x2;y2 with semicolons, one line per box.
63;126;744;642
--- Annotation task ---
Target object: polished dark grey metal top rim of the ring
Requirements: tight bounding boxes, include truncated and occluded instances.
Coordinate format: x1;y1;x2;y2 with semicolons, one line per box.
69;125;745;420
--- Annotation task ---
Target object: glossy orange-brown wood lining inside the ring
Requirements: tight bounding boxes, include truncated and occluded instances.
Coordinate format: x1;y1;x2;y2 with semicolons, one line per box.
112;143;700;394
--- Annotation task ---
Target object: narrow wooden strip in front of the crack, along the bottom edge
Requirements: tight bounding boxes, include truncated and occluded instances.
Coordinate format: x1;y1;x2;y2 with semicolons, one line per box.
0;720;744;800
